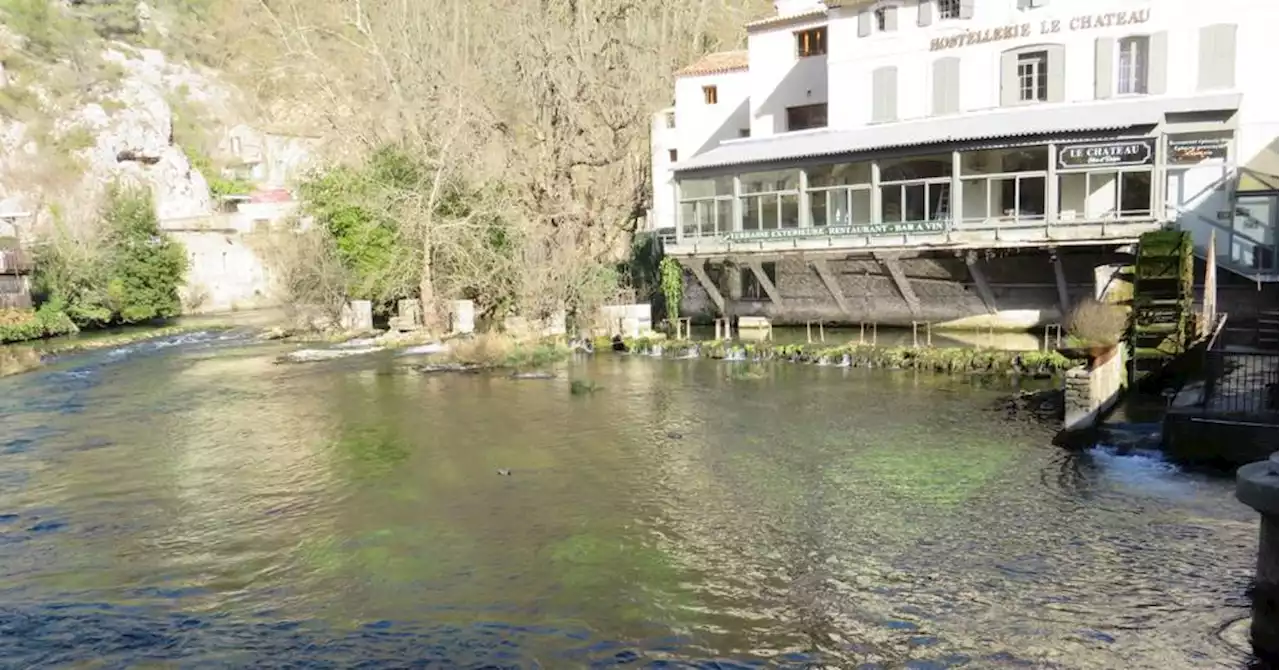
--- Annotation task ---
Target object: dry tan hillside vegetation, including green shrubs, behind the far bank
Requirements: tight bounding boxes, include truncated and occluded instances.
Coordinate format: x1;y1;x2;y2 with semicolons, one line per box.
0;0;769;324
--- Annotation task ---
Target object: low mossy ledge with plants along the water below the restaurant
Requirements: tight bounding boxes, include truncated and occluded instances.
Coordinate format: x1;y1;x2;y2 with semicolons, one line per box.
591;338;1080;377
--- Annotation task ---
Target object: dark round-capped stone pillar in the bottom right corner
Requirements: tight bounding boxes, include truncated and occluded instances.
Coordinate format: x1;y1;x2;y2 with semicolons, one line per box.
1235;452;1280;664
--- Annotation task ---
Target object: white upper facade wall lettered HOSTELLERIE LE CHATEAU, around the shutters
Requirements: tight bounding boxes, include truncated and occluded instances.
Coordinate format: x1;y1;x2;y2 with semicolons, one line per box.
676;0;1280;138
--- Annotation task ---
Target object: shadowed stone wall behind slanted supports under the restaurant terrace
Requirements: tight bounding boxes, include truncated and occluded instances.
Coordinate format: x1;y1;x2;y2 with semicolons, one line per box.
682;247;1125;329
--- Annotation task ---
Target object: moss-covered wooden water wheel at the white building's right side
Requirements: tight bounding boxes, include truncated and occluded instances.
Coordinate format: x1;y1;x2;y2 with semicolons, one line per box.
1130;231;1196;380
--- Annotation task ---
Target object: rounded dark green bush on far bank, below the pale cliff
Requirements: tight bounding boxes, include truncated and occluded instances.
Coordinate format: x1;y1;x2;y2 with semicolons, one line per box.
36;184;187;325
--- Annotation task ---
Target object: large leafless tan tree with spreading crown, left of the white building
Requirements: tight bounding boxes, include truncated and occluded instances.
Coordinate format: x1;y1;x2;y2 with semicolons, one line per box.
238;0;767;322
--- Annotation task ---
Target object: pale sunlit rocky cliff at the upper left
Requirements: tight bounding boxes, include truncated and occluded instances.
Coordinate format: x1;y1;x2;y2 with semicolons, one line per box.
0;18;243;236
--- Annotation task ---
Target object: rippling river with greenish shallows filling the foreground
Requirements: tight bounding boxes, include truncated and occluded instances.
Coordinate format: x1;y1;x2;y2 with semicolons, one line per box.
0;333;1257;669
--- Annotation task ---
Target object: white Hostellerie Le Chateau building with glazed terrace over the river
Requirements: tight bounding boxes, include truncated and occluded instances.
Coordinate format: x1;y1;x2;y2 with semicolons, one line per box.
654;0;1280;327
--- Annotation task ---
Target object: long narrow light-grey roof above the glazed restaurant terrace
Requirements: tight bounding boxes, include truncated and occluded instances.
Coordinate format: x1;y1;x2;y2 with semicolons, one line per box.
673;94;1242;172
